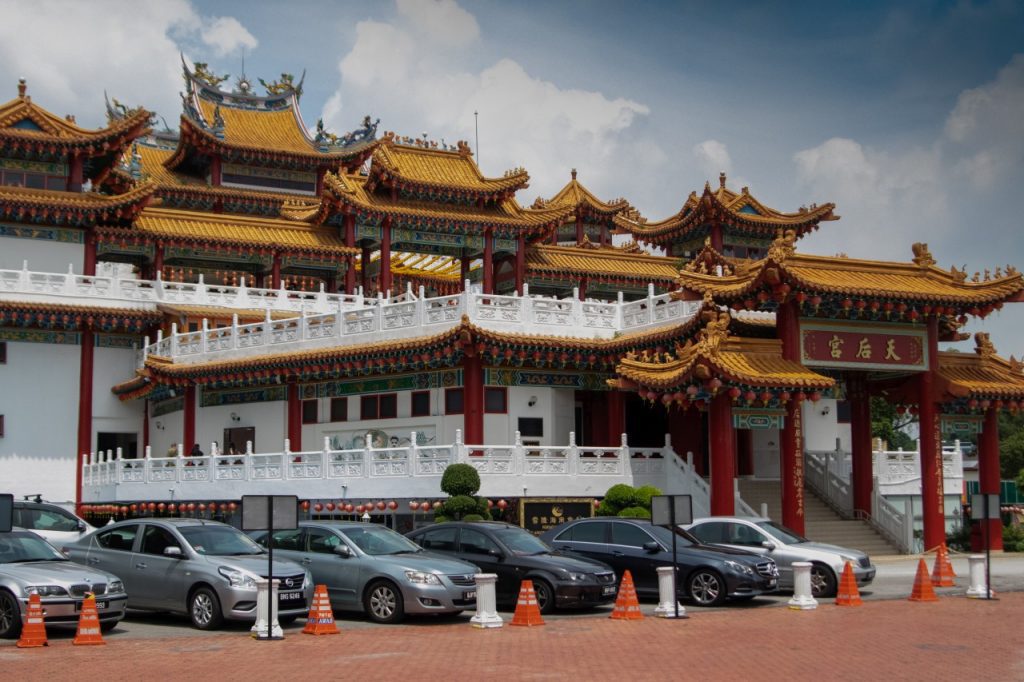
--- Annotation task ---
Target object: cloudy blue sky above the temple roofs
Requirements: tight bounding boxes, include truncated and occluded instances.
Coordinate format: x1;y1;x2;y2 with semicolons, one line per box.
0;0;1024;350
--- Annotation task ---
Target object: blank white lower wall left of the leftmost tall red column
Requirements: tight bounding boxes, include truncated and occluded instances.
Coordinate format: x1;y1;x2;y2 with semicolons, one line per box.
0;339;81;502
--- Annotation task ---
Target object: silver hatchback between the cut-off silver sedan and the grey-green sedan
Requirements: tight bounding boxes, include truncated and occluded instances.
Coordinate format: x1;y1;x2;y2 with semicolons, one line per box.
63;518;313;630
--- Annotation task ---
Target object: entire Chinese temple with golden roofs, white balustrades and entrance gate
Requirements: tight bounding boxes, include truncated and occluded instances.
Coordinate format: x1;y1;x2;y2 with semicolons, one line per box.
0;59;1024;549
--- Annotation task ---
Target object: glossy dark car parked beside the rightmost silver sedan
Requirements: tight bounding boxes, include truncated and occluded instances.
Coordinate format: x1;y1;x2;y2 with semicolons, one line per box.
541;516;778;606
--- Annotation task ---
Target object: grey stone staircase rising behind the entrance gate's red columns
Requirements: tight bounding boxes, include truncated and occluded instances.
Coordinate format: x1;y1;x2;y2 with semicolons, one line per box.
739;478;899;557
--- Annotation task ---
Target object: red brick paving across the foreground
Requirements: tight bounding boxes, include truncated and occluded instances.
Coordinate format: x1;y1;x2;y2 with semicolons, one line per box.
0;593;1024;682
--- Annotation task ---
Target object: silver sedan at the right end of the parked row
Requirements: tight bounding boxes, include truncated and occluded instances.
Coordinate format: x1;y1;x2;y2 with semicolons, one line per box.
684;516;874;598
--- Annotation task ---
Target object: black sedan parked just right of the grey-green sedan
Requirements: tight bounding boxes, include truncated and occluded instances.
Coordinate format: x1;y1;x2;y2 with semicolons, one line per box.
408;521;616;613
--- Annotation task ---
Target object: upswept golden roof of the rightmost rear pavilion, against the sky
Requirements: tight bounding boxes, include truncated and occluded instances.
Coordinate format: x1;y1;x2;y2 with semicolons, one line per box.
615;174;839;243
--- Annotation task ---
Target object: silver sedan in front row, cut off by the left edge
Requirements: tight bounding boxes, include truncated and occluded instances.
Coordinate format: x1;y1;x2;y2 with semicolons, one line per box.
0;530;128;638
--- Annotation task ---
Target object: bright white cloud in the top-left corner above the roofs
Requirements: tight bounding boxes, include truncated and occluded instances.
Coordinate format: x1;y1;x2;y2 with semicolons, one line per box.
0;0;255;126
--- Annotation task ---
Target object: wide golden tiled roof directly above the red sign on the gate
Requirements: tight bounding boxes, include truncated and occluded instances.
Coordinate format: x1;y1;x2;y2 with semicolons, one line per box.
679;238;1024;304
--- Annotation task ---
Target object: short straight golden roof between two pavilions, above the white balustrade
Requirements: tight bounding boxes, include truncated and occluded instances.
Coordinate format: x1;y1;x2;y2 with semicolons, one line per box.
526;245;679;283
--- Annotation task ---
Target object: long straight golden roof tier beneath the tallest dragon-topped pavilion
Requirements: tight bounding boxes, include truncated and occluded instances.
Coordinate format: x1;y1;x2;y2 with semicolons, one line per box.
134;208;358;255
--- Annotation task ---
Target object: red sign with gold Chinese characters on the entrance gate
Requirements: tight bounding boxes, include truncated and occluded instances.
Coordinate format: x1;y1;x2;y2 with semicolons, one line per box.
800;323;928;372
